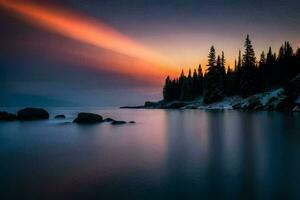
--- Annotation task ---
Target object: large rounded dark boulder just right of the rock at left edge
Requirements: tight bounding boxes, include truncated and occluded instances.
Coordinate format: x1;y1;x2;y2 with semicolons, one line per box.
17;108;49;120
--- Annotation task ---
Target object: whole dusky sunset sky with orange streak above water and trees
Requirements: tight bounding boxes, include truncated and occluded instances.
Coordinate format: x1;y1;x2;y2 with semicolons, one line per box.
0;0;300;107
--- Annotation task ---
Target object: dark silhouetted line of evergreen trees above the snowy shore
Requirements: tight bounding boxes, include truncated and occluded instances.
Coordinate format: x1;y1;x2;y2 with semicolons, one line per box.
163;35;300;103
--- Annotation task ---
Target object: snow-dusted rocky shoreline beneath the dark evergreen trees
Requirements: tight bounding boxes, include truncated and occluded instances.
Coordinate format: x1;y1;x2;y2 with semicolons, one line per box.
120;75;300;112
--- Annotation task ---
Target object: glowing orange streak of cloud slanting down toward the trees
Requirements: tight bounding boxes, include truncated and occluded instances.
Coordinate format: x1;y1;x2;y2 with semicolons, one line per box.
0;0;178;81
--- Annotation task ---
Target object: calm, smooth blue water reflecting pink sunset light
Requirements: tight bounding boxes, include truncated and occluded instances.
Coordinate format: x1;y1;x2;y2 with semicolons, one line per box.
0;109;300;200
